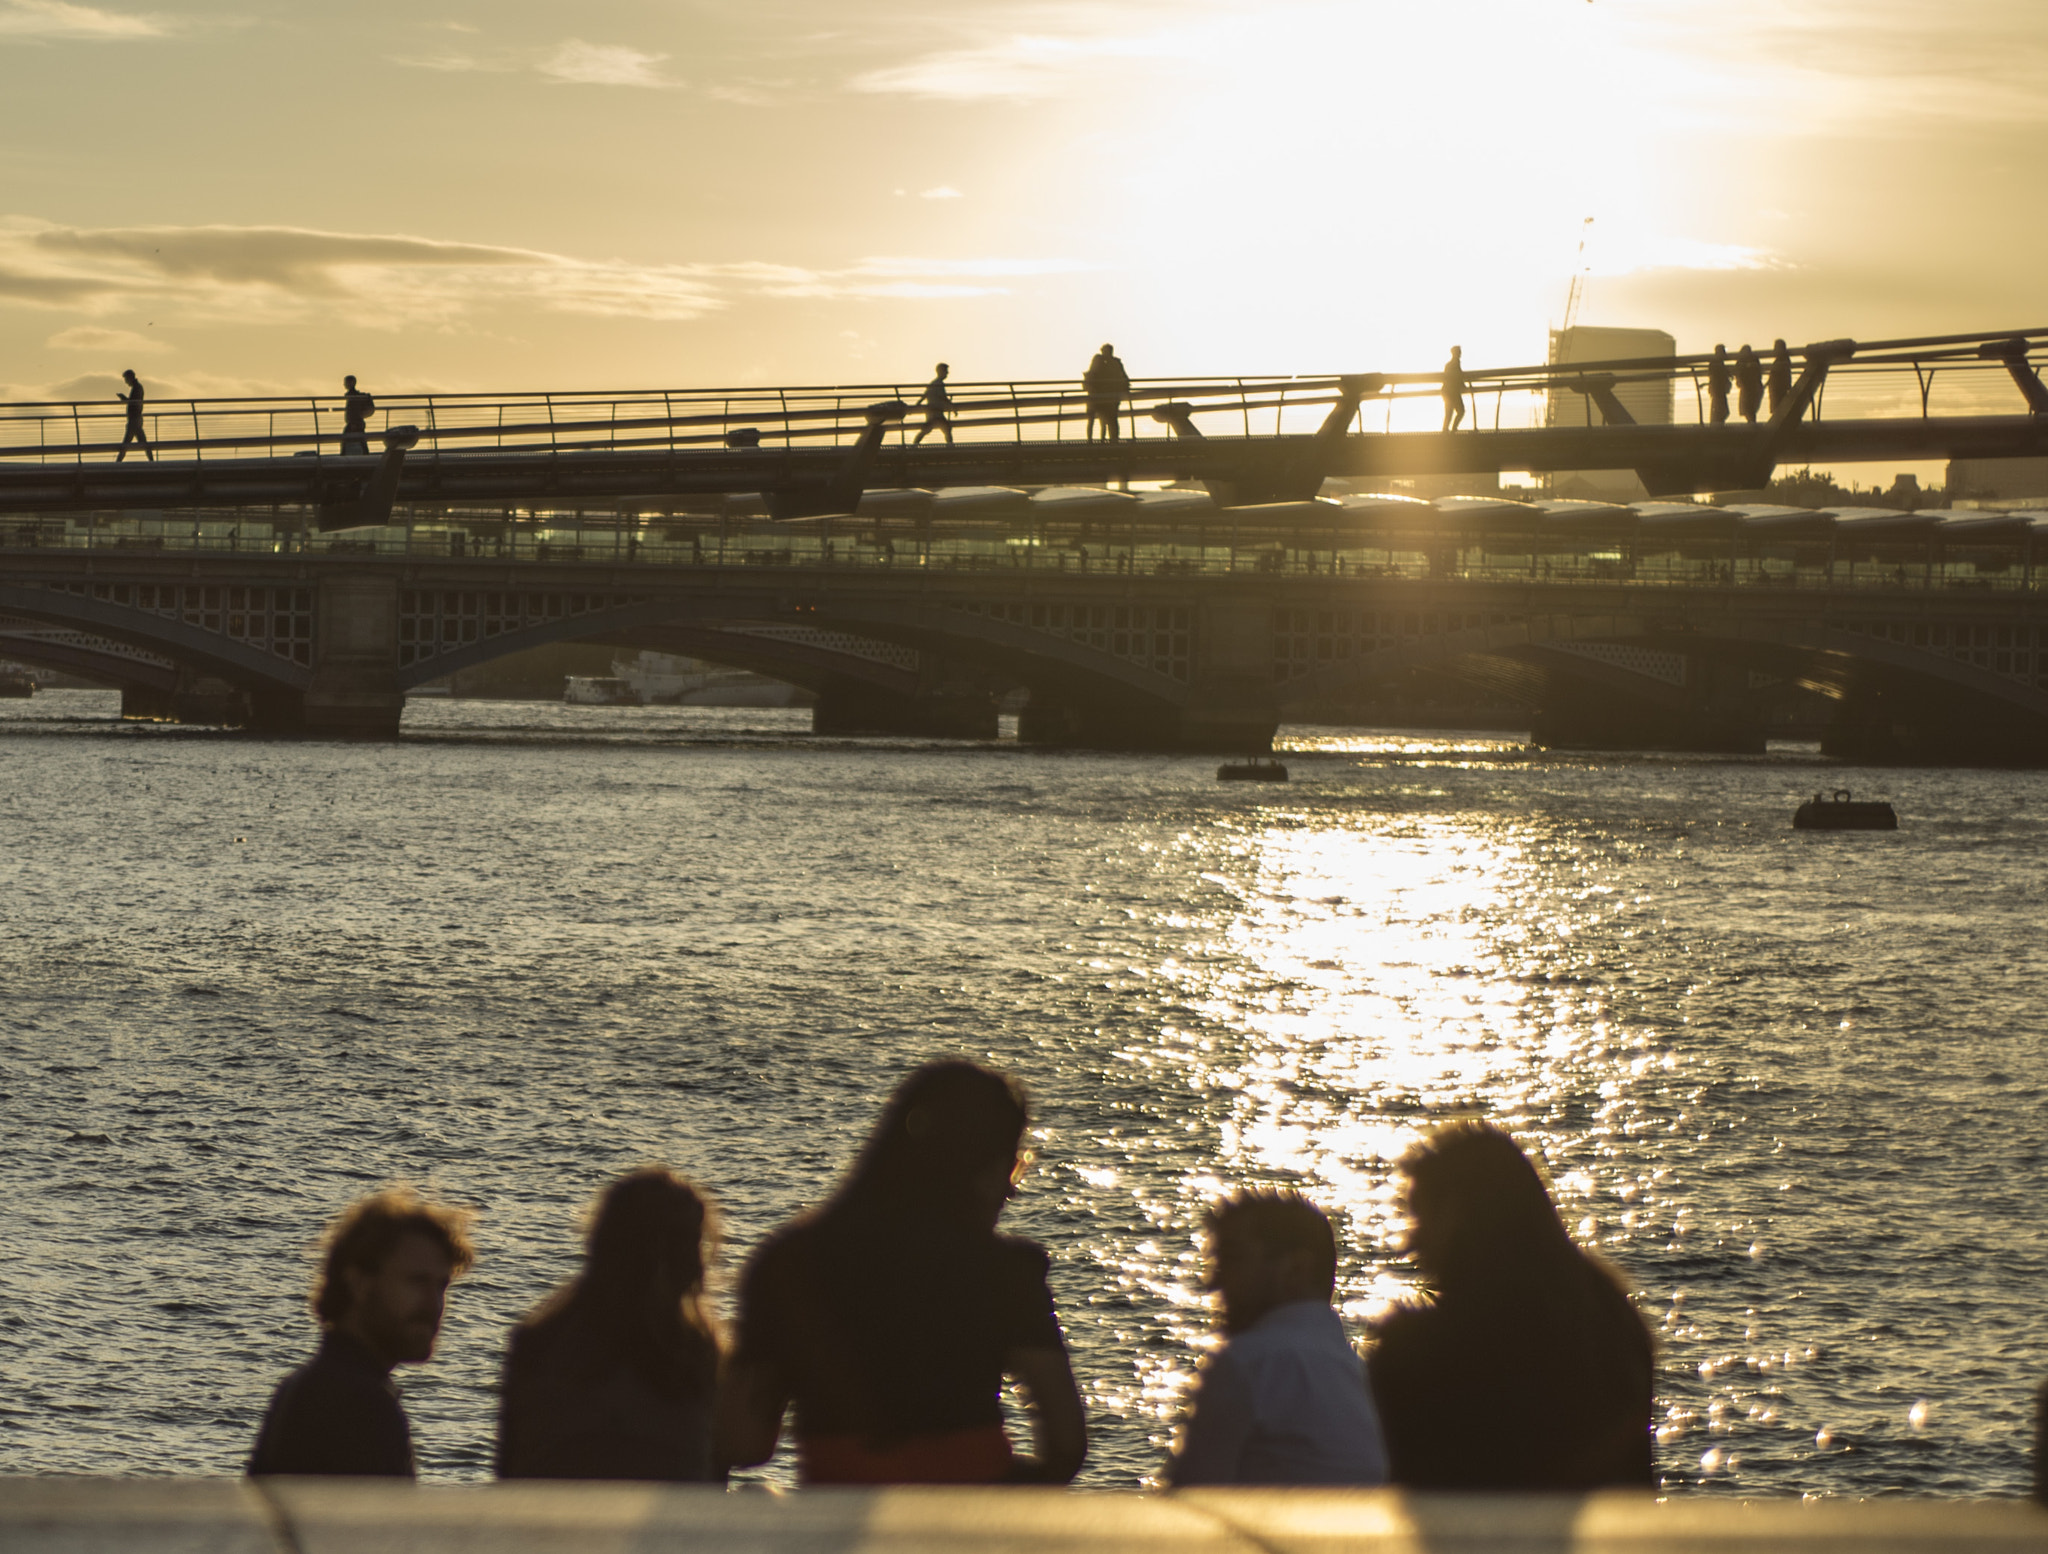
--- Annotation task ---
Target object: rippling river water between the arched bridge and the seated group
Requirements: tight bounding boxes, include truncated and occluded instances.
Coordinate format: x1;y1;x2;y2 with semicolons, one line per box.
0;692;2048;1495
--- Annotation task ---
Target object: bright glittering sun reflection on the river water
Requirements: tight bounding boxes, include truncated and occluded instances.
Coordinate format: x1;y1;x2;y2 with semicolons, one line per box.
1090;806;1661;1474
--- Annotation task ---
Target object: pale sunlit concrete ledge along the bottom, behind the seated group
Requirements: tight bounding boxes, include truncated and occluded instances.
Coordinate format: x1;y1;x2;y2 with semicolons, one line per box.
0;1478;2048;1554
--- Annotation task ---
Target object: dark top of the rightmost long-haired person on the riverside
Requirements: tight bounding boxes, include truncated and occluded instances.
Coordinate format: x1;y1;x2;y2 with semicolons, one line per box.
1368;1255;1653;1491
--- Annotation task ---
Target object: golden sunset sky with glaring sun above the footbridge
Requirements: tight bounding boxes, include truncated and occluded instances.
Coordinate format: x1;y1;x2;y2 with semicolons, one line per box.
0;0;2048;419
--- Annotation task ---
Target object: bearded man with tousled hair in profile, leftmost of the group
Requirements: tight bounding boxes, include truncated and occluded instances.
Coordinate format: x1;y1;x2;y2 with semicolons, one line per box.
248;1188;475;1478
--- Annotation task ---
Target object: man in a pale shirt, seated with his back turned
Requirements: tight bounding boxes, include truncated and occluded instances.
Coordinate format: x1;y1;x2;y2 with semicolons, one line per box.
1165;1192;1386;1488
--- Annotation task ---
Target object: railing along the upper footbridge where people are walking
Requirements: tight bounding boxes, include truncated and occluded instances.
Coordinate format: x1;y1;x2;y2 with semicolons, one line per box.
12;330;2048;467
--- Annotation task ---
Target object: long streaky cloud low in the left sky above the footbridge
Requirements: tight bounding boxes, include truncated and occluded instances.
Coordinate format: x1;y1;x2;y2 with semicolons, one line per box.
0;219;1092;327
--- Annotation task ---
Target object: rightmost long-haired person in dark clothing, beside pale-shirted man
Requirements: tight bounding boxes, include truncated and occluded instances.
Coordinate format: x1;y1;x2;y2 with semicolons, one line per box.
1370;1122;1651;1491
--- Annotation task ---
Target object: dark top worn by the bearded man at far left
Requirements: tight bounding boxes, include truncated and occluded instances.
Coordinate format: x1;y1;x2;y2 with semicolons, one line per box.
248;1333;418;1478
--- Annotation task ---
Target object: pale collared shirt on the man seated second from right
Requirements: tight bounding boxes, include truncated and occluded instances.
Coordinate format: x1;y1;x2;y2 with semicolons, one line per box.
1165;1300;1386;1488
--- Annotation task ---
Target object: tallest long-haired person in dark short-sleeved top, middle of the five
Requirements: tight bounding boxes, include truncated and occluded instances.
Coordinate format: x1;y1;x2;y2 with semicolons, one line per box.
719;1063;1087;1484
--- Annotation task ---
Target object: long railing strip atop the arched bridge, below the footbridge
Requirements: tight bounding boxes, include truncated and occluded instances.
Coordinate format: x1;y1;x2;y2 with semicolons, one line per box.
0;507;2048;592
